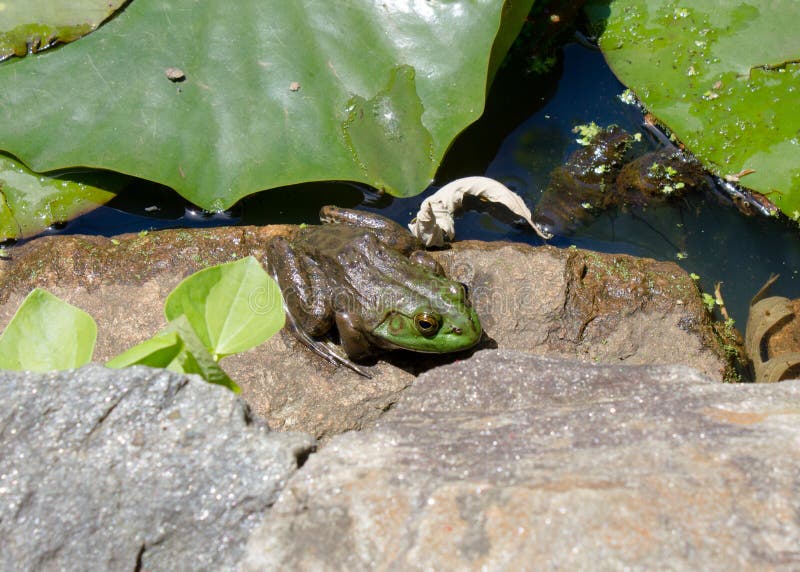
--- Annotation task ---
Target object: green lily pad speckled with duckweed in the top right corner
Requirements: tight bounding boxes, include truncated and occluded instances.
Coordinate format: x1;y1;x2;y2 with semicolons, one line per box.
590;0;800;218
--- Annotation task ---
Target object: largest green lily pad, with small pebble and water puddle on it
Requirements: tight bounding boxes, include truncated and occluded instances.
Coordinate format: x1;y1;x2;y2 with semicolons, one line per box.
0;0;533;210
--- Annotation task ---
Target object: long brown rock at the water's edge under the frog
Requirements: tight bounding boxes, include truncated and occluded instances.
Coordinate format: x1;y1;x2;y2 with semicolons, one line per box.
0;227;733;440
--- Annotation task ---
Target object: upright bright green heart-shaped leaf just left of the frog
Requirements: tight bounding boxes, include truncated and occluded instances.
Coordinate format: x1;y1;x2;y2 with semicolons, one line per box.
164;256;284;360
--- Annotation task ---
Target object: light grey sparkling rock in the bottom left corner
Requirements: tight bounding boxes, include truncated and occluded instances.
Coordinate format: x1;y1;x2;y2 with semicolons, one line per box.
0;366;313;570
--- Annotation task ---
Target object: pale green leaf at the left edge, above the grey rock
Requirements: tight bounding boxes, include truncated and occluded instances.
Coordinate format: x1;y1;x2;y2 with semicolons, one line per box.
0;288;97;372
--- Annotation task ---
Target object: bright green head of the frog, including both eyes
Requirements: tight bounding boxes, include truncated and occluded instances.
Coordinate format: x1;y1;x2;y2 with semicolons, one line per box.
372;280;482;353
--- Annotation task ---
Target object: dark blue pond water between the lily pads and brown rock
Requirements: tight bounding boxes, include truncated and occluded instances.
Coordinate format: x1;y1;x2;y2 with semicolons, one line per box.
32;44;800;329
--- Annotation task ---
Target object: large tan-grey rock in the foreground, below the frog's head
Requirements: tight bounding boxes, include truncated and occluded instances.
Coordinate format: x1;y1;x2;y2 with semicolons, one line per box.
242;351;800;571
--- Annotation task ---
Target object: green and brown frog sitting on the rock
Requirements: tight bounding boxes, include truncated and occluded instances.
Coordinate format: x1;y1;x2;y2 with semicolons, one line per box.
268;206;482;377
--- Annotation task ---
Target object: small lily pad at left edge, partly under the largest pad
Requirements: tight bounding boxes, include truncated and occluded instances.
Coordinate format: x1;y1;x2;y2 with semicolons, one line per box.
0;154;124;242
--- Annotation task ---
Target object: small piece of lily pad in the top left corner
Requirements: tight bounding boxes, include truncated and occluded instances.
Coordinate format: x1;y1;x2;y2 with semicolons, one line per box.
0;0;125;60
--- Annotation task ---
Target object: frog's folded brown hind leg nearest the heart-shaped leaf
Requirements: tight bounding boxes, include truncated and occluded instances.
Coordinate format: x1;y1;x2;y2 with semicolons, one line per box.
267;237;333;336
